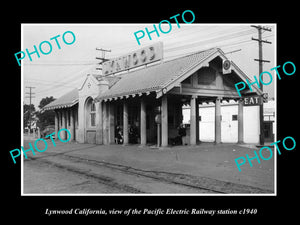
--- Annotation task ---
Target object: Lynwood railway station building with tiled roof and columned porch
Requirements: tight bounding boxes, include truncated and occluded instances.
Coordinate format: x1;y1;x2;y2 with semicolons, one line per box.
44;43;262;147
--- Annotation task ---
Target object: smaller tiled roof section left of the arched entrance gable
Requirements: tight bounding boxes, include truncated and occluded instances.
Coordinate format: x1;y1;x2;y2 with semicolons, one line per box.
43;88;78;110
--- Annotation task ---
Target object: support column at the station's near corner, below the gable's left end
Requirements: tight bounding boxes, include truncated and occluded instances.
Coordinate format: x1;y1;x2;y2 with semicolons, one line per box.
161;95;168;147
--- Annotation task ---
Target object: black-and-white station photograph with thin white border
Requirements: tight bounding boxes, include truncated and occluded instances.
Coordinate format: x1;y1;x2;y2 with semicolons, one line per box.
20;23;276;196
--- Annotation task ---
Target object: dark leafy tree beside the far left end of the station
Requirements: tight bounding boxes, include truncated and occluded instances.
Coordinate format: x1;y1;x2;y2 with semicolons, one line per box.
36;96;55;130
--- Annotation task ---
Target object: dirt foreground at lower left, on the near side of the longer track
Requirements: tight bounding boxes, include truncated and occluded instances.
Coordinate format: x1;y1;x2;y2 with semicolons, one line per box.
24;156;218;194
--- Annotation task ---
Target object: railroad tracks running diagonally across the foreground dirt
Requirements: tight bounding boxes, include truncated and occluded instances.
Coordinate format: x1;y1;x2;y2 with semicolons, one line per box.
25;154;272;194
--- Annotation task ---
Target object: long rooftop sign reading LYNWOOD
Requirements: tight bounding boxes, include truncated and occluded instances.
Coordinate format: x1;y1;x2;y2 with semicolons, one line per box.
102;42;163;75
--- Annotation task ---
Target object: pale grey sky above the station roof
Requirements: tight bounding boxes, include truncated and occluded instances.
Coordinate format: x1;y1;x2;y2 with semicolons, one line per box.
22;23;276;110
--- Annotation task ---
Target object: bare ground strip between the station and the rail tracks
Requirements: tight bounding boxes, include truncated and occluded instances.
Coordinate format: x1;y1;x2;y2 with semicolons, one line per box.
24;140;274;193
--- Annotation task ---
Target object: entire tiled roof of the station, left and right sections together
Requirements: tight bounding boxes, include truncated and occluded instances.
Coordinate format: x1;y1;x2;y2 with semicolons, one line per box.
43;48;260;110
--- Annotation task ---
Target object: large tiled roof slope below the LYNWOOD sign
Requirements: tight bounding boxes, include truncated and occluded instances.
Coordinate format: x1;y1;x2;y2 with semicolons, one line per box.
96;48;218;100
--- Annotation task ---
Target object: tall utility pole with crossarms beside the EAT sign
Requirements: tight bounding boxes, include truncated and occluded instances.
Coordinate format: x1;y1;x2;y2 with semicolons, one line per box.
251;25;272;145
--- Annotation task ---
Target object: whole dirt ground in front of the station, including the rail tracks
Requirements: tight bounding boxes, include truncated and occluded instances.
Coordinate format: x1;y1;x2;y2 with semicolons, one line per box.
24;140;274;194
